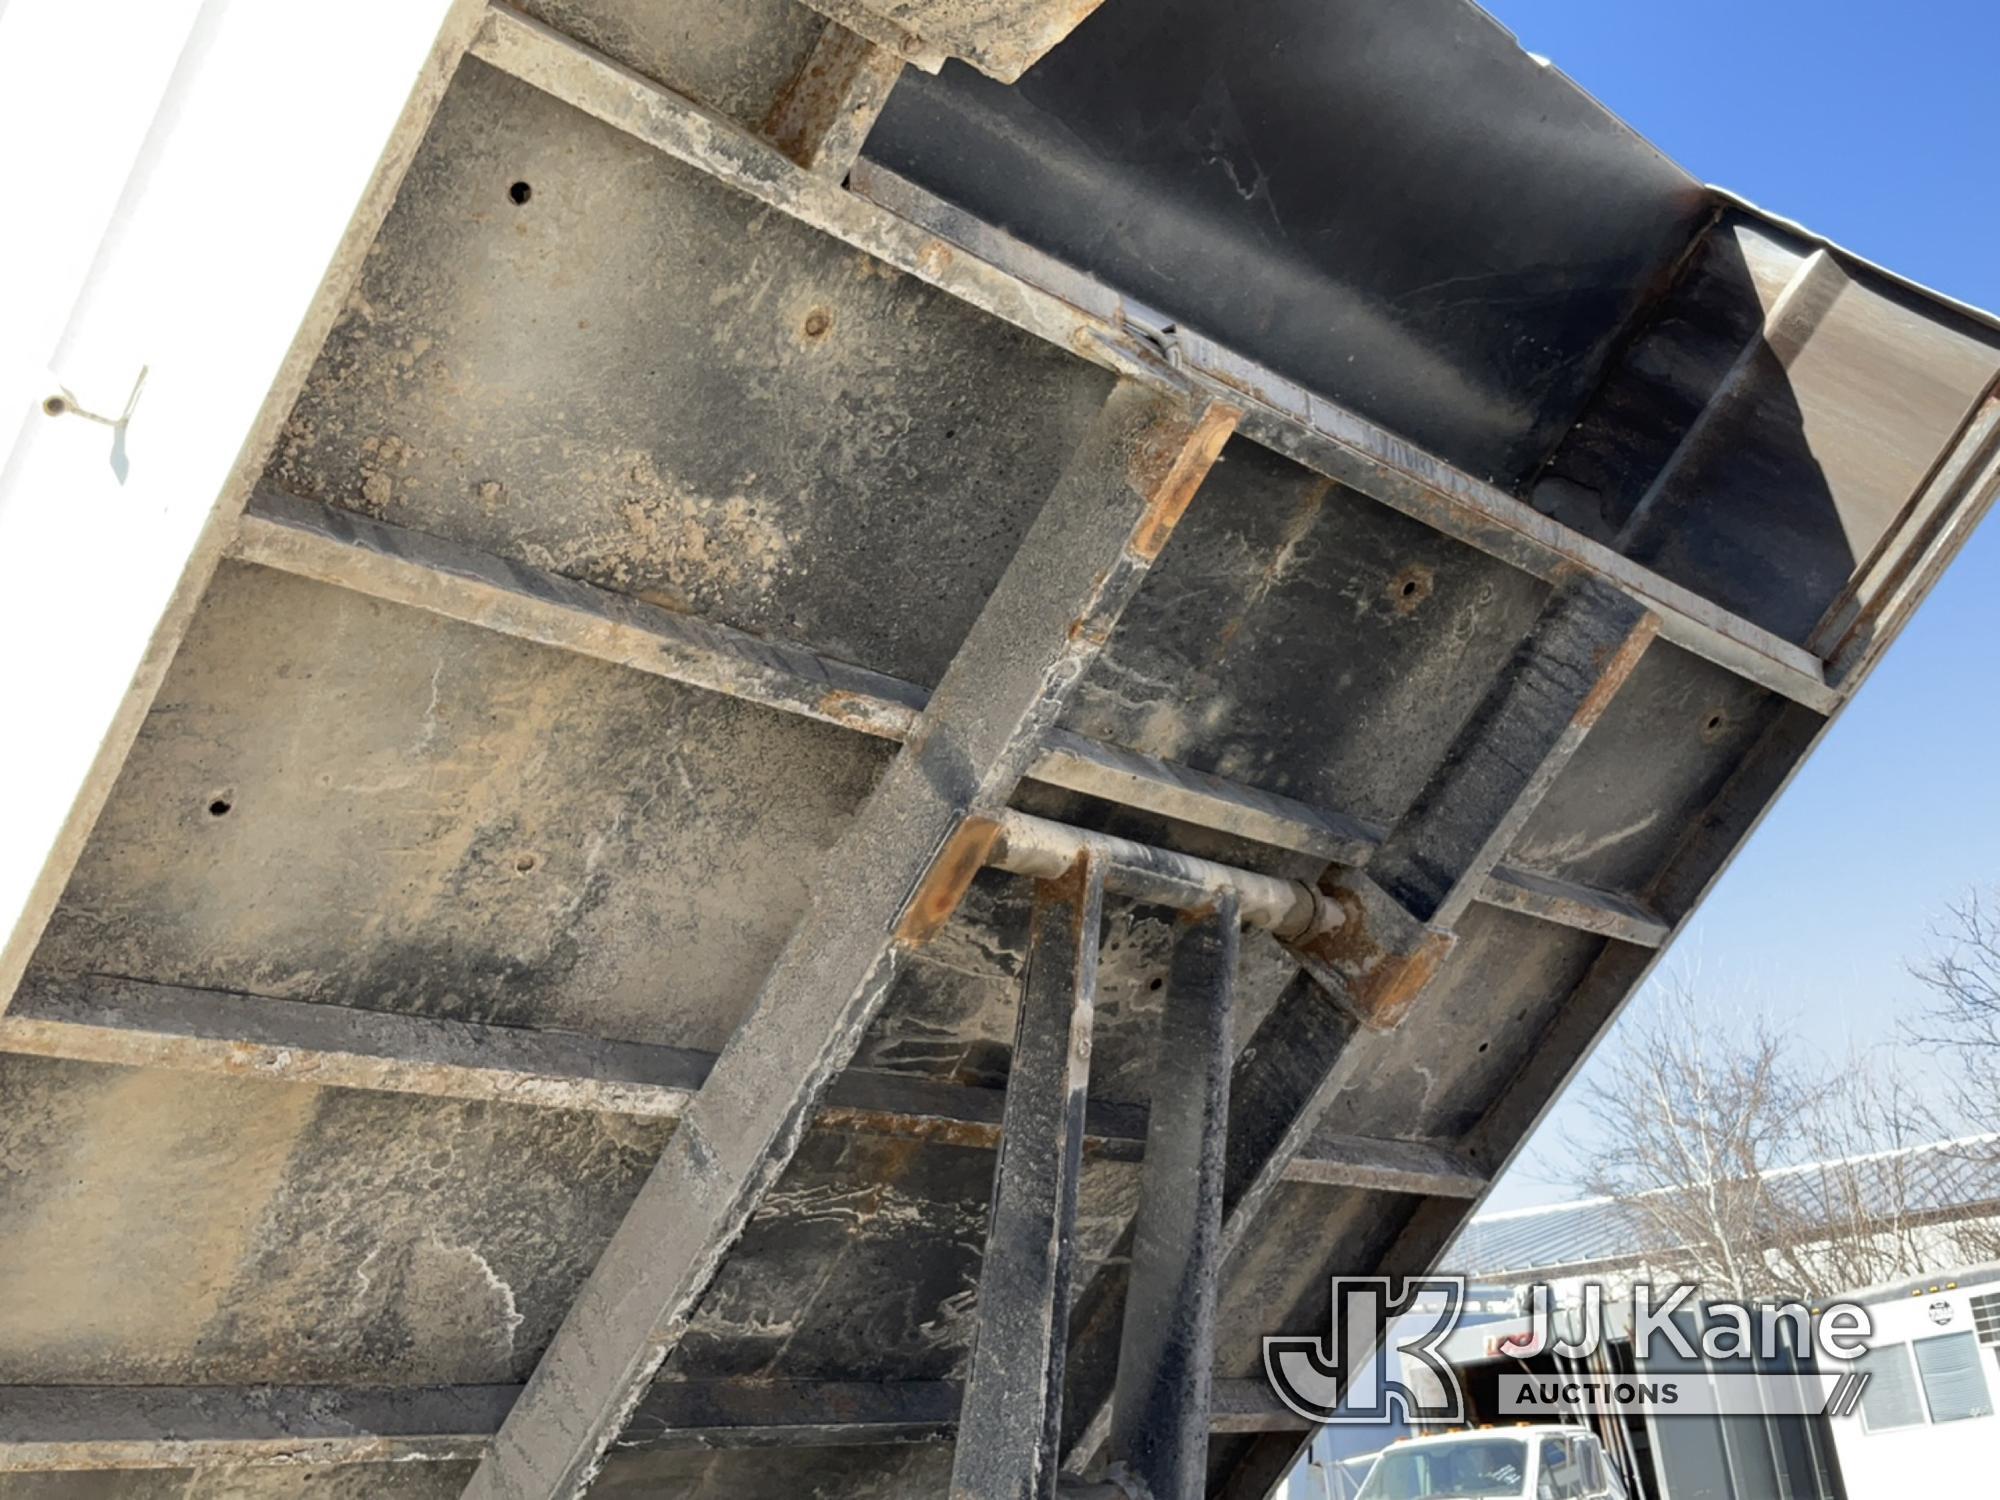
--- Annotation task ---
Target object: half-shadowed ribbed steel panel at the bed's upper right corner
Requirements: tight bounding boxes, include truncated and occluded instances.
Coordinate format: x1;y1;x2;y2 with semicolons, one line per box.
1536;212;2000;646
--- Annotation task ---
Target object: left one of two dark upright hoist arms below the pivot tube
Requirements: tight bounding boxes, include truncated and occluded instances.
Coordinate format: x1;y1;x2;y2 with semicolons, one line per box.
950;854;1104;1500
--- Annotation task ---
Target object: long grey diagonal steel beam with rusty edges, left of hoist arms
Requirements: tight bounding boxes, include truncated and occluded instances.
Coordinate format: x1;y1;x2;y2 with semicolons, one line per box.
466;382;1236;1500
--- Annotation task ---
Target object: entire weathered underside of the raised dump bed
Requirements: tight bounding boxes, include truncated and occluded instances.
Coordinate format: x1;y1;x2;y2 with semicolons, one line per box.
0;0;2000;1500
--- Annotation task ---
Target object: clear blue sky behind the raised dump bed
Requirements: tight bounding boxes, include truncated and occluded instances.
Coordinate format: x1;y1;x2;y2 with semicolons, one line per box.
1486;0;2000;1208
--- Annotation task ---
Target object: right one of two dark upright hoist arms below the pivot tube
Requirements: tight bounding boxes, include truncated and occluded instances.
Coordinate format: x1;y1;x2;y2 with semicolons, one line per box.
1110;896;1238;1500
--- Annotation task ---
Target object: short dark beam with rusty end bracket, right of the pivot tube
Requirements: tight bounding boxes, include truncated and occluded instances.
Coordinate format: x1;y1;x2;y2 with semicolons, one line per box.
1296;576;1660;1030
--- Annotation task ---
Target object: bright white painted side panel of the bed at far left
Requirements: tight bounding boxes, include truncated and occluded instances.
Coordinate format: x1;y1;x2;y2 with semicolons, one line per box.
0;0;480;1010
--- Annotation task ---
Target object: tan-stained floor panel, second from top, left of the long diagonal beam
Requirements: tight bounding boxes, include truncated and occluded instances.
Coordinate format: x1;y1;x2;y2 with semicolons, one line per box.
27;564;890;1052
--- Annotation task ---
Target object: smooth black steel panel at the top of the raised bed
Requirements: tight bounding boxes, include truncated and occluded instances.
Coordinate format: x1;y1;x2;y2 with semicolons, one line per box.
870;0;1708;484
